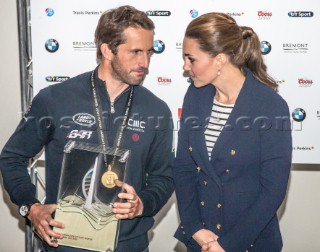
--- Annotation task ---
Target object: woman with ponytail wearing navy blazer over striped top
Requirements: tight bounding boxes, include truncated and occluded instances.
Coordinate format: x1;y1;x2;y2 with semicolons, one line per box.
174;13;292;252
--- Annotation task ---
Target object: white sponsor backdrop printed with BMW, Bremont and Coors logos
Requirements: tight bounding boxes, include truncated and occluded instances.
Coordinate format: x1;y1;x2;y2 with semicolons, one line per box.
31;0;320;164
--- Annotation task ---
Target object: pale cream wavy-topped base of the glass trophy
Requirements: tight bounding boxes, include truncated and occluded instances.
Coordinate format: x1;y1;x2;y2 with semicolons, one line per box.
53;199;119;252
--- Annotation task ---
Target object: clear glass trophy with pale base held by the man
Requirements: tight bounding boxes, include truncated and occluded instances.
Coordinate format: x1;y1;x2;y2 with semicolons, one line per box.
54;141;130;252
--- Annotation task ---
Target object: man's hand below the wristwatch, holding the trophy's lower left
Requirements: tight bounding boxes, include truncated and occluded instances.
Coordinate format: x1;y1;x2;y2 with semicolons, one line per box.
28;204;64;247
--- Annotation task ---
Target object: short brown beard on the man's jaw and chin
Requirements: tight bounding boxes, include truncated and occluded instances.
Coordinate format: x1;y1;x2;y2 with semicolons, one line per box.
111;56;148;85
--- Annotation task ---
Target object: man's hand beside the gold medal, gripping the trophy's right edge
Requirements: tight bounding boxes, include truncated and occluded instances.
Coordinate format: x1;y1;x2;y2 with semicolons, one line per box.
112;183;143;219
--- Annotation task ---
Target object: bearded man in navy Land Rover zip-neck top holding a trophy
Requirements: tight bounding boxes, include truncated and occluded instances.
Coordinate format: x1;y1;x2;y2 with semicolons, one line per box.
0;6;173;252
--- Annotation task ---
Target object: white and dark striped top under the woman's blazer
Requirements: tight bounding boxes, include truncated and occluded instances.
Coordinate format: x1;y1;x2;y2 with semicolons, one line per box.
204;99;234;159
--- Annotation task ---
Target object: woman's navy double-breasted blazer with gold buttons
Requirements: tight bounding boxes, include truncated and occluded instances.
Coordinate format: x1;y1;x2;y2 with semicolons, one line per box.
174;70;292;252
